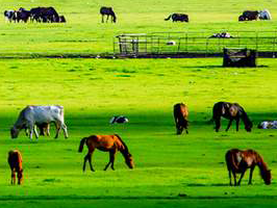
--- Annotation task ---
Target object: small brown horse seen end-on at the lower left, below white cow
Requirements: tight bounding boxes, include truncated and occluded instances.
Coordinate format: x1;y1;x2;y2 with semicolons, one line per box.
8;150;23;185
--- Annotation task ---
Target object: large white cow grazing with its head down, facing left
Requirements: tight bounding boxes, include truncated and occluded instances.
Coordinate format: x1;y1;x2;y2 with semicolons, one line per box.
11;105;68;139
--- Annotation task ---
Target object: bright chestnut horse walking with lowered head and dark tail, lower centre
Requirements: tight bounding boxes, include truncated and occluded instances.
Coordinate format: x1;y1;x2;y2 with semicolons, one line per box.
79;134;134;171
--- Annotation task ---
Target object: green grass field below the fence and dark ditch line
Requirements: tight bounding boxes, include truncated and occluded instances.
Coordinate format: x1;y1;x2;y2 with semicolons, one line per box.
0;59;277;207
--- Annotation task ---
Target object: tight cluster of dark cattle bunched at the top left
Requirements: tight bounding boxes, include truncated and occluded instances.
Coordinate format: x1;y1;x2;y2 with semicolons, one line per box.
4;7;66;23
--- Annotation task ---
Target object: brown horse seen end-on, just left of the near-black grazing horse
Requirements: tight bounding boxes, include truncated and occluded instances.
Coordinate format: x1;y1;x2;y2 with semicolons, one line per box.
173;103;189;134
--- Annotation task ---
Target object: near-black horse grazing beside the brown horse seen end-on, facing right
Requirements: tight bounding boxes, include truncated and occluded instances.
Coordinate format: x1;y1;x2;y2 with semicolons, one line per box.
213;102;253;132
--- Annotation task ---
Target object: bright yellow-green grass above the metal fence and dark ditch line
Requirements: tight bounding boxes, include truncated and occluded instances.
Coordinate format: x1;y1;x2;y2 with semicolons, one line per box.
0;0;277;56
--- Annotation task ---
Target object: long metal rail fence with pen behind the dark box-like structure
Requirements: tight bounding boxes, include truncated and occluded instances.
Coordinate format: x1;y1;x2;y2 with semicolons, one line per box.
114;31;277;55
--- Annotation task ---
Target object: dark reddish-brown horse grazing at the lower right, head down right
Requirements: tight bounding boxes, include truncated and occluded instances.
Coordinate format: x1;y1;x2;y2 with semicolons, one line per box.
225;149;271;186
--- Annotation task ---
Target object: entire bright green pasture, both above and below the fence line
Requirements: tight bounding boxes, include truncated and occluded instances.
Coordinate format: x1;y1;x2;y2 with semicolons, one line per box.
0;0;277;207
